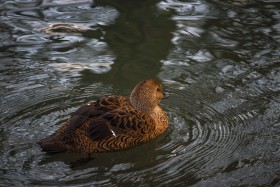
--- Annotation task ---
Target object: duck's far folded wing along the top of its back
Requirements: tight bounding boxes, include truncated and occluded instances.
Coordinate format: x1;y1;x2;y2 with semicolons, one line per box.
65;96;129;135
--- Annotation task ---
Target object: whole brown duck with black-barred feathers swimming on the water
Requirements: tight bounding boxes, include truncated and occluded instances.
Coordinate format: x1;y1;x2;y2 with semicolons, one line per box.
38;80;168;153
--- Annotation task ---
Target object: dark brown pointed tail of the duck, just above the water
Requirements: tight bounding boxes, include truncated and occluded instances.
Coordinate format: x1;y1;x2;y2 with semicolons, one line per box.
38;136;65;153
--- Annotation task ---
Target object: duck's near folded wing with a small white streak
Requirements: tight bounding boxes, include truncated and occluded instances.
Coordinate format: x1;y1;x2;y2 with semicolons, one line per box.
88;107;156;141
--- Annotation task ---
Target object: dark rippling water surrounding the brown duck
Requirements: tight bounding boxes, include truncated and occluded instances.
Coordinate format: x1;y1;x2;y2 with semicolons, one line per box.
0;0;280;186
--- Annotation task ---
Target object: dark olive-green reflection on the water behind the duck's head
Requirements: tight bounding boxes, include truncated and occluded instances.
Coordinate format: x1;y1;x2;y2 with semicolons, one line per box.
81;0;176;87
